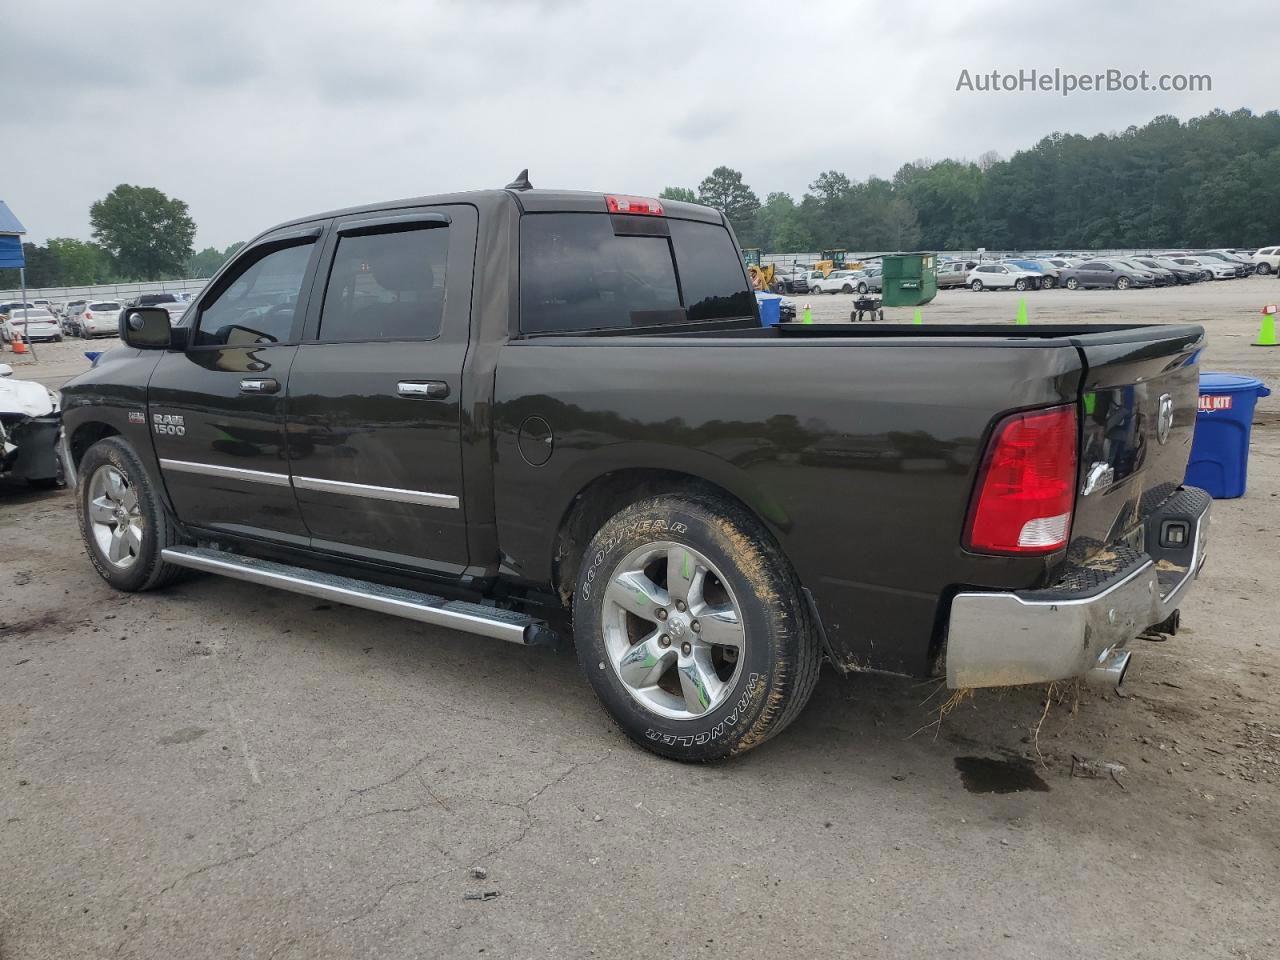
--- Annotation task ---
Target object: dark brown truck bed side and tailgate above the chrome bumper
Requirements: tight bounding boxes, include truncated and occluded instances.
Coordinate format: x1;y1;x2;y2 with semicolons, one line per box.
494;324;1203;675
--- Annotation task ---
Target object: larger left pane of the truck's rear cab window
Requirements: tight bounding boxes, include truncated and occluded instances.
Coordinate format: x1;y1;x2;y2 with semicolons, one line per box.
520;214;685;333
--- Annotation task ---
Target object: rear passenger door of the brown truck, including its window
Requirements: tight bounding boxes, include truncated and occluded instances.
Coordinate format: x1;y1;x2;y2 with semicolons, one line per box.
288;205;477;576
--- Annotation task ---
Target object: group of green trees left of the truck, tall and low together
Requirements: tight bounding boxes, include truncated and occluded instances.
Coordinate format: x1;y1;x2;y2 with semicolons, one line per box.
0;183;244;289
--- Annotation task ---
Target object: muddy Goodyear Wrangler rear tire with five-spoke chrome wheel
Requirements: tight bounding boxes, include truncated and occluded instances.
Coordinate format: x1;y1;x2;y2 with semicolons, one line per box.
573;494;820;762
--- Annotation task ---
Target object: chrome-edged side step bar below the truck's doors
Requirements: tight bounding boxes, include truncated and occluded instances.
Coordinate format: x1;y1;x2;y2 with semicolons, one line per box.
160;547;556;646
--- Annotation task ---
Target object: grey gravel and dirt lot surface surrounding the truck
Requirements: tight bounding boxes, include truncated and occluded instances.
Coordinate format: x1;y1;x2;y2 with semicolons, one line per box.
0;279;1280;960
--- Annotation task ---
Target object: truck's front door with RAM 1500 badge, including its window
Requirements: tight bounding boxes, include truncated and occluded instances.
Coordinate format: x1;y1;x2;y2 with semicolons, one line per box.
147;227;321;545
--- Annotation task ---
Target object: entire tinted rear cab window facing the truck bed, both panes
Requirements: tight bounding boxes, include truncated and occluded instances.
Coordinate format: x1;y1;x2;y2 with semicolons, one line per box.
520;214;755;333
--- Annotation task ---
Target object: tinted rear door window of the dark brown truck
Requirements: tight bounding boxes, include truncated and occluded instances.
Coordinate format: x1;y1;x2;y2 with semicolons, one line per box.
319;225;449;340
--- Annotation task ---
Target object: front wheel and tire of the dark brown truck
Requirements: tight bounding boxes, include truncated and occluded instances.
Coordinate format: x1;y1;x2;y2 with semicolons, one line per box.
76;436;183;593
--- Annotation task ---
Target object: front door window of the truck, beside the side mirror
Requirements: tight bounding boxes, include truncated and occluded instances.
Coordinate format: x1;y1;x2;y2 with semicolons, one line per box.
193;241;315;347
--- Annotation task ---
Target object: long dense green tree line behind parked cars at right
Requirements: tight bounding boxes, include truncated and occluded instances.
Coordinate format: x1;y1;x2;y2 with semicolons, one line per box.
662;110;1280;253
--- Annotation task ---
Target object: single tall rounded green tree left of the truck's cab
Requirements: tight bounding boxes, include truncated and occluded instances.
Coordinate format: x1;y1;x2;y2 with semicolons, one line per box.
88;183;196;280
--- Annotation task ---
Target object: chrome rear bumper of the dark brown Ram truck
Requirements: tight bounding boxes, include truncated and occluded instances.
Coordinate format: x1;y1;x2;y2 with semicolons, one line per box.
946;486;1212;687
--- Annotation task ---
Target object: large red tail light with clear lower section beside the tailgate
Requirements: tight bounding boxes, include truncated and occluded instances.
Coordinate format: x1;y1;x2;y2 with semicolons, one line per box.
964;406;1079;554
